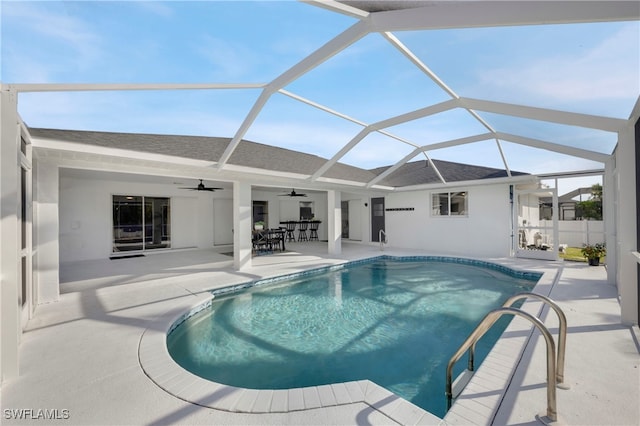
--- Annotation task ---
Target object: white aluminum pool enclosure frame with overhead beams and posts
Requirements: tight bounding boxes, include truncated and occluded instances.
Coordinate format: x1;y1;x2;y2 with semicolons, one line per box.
0;0;640;386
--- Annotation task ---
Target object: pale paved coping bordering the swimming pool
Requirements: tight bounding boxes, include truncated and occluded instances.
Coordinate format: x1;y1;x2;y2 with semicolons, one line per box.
138;255;555;424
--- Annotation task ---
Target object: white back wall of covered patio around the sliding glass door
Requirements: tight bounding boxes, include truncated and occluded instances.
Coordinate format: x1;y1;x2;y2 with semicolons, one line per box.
55;170;336;263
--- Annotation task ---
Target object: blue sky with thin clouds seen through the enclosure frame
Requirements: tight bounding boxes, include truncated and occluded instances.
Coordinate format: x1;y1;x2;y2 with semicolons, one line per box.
0;1;640;193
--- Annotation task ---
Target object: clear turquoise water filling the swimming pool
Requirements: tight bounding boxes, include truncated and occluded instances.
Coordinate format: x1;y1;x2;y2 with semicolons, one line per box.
167;258;535;417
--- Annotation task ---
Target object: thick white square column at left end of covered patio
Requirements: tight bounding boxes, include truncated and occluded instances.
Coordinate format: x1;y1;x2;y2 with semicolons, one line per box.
34;162;60;304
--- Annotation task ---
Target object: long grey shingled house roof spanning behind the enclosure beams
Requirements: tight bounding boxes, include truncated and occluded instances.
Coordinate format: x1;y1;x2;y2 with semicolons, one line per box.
29;128;527;187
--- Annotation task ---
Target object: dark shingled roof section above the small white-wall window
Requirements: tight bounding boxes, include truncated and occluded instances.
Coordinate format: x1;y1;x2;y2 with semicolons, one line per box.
371;160;528;187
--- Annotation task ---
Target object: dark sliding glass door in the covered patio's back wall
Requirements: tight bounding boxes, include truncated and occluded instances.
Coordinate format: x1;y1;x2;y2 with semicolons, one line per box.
112;195;171;253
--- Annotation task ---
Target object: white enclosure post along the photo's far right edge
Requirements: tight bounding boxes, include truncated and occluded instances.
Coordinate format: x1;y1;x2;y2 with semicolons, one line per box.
615;124;638;324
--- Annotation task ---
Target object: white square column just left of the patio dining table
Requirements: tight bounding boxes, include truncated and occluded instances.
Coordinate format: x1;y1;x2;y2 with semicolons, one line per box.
233;182;251;271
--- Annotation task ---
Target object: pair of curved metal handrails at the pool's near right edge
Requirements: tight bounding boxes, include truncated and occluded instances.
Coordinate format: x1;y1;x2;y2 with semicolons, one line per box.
445;292;569;425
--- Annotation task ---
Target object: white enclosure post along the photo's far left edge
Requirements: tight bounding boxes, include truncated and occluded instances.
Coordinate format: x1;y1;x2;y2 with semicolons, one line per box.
0;87;22;383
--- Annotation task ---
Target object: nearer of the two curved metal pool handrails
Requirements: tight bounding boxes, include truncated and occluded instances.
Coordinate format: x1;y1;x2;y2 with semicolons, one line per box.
446;307;558;422
